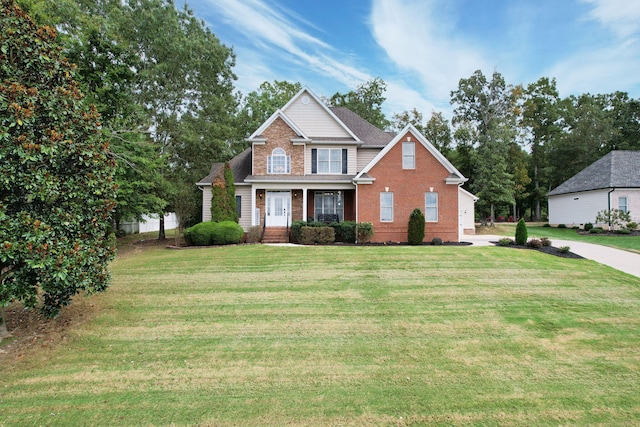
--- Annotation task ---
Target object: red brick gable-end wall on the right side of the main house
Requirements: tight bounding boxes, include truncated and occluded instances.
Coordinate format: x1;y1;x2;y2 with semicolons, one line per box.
358;133;458;242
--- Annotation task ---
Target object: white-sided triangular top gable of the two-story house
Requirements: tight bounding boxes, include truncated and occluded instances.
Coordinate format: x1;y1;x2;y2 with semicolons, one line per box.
282;89;358;140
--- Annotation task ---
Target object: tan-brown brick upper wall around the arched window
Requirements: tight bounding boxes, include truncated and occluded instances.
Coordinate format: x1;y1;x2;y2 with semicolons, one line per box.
253;117;304;175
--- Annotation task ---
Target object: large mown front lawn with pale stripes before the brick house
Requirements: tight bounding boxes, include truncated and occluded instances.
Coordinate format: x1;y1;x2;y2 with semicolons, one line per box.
0;245;640;426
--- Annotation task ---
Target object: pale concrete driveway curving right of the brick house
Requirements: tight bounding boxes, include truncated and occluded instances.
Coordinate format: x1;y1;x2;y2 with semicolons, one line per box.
461;234;640;277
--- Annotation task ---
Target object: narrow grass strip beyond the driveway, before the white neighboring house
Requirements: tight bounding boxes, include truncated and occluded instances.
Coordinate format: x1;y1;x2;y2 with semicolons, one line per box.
481;223;640;253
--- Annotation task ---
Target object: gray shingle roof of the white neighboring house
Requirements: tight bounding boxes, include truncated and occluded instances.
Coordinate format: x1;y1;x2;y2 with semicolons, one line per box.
548;150;640;196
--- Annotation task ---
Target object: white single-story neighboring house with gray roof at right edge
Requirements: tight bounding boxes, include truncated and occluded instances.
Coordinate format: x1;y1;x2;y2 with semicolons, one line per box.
548;151;640;226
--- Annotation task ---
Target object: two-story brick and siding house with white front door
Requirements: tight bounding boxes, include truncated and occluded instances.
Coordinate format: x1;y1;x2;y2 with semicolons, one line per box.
197;89;477;242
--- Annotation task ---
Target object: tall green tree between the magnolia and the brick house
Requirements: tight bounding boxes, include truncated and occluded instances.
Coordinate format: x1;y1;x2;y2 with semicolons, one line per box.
114;0;237;238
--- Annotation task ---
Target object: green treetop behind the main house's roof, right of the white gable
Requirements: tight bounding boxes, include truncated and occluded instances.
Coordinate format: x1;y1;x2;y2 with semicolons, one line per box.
329;77;391;129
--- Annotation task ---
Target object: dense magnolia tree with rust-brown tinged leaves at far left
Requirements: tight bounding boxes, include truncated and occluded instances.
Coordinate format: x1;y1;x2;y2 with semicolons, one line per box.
0;0;116;316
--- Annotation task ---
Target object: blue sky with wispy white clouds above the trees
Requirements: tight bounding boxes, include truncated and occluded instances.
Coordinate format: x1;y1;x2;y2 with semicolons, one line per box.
185;0;640;118
